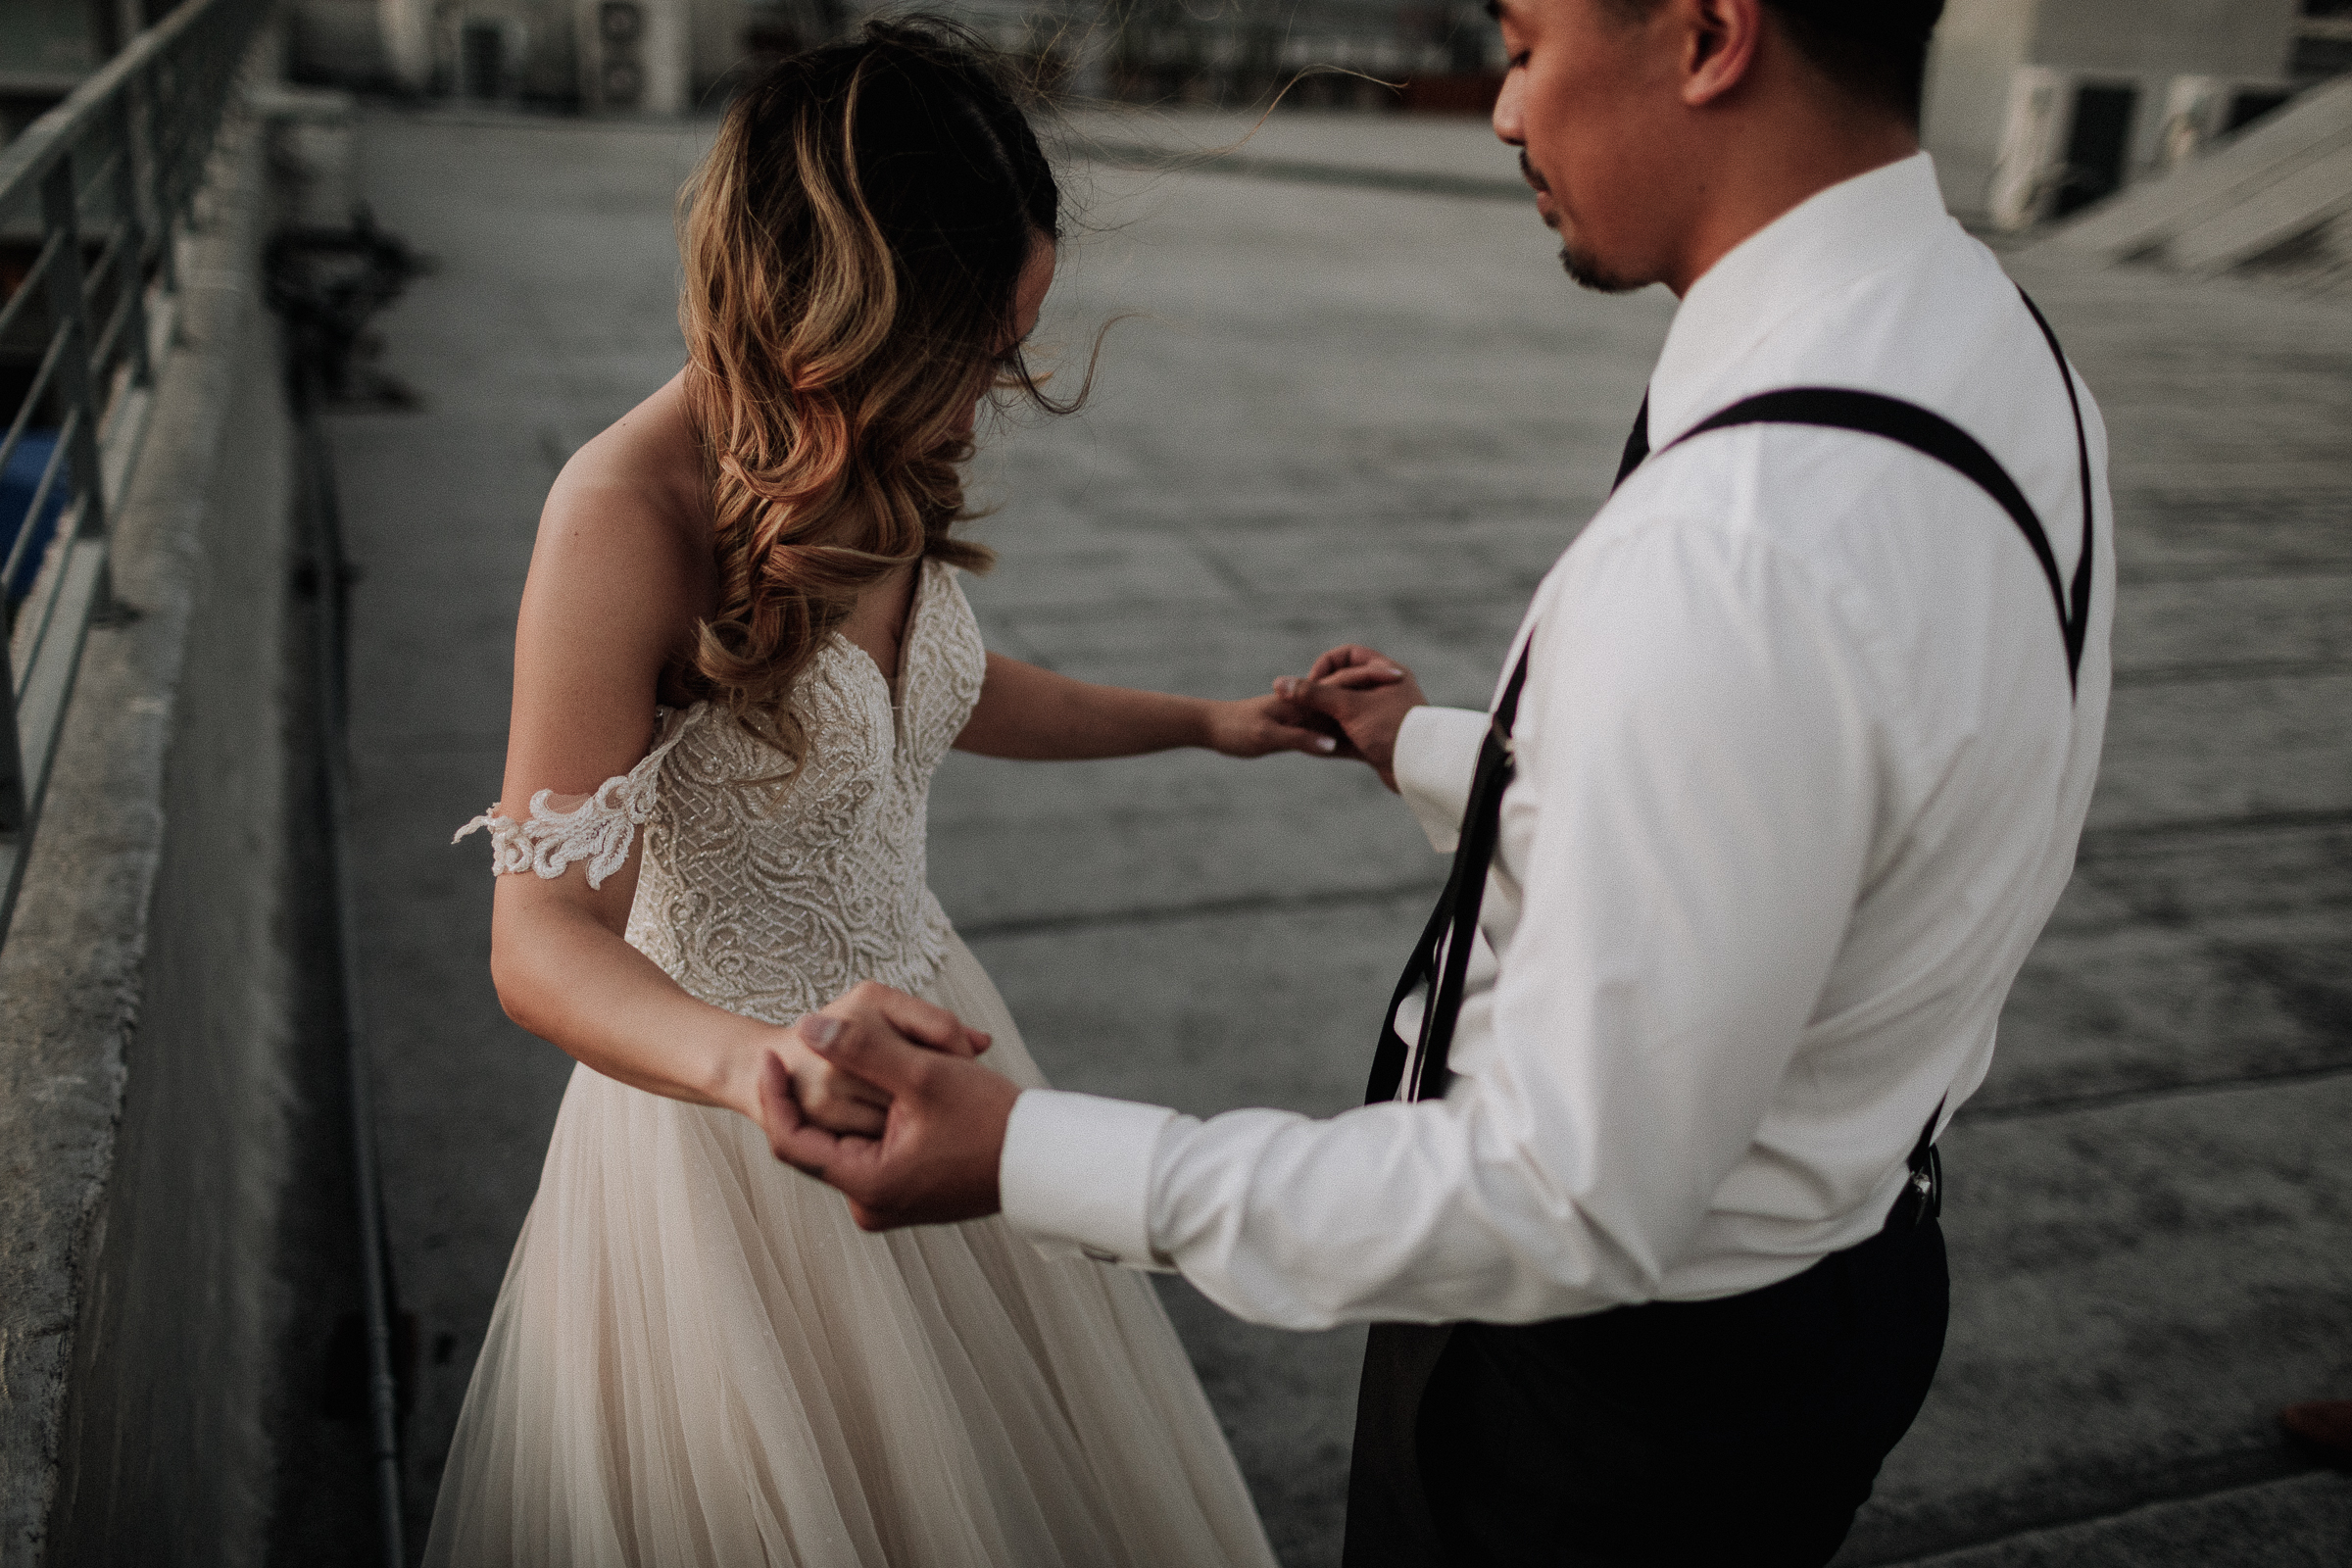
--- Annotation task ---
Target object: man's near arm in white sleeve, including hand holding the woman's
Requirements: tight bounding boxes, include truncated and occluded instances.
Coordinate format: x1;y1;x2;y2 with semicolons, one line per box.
776;531;1880;1328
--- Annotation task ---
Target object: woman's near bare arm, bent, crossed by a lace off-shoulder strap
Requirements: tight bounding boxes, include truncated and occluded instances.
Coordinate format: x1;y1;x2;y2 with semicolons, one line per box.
489;397;969;1131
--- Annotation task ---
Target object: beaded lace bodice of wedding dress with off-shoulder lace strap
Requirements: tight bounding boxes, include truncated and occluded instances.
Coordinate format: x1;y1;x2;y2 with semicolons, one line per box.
459;562;988;1022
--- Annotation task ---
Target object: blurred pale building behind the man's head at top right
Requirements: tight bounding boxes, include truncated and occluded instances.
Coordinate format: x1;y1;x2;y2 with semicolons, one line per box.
1924;0;2352;228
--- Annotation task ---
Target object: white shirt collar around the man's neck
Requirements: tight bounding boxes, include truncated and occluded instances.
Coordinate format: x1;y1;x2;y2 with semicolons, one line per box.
1648;153;1952;449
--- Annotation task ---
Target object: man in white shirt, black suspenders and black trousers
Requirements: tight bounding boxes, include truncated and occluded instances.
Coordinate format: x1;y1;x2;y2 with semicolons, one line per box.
766;0;2115;1568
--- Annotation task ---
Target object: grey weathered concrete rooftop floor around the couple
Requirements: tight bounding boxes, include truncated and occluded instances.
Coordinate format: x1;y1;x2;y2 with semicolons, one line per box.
318;113;2352;1568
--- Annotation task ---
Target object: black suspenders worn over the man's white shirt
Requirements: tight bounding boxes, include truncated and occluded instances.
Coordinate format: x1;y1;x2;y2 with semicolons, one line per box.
1364;289;2091;1220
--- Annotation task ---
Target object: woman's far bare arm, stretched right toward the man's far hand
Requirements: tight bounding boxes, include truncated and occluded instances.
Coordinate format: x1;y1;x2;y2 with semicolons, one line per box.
955;654;1339;761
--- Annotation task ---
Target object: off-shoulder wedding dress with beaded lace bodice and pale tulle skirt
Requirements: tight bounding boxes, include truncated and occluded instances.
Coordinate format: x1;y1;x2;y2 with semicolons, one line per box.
425;562;1275;1568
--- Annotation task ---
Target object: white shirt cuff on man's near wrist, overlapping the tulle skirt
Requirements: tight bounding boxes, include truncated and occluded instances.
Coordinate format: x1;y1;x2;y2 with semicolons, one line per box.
998;1089;1176;1269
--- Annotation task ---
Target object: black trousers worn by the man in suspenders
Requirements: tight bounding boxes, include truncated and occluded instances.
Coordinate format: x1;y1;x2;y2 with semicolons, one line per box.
1346;1218;1947;1568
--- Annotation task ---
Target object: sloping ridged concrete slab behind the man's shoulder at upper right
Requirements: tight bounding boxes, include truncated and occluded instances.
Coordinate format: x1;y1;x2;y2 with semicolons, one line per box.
2034;80;2352;272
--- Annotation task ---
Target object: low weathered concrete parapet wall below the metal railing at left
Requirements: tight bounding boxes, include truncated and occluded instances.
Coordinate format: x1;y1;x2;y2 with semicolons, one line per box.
0;101;313;1566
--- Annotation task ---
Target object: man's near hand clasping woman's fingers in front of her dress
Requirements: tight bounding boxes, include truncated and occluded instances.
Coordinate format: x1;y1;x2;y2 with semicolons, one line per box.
760;985;1021;1230
